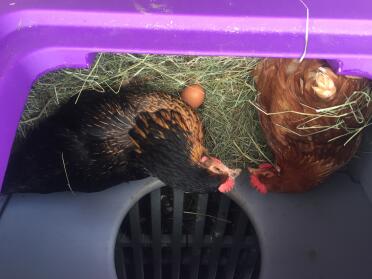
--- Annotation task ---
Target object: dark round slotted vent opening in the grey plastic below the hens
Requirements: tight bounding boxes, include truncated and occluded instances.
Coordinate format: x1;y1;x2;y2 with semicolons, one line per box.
116;187;259;279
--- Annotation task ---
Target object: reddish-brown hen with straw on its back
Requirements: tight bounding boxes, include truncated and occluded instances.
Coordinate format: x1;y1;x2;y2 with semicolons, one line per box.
249;59;371;193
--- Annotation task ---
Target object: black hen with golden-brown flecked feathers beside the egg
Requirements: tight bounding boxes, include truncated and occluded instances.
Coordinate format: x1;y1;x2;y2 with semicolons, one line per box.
3;90;238;193
